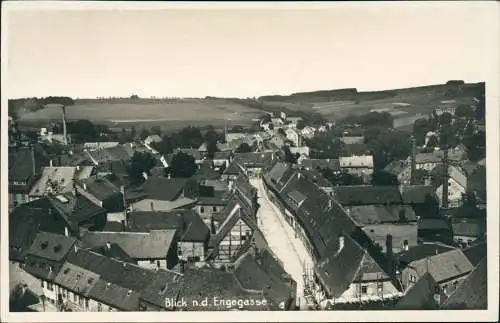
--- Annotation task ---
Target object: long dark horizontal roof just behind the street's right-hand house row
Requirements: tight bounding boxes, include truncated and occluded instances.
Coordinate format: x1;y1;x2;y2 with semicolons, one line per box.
333;185;402;205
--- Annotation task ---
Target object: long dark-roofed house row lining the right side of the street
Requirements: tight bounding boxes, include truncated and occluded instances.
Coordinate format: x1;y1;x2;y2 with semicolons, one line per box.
264;163;401;306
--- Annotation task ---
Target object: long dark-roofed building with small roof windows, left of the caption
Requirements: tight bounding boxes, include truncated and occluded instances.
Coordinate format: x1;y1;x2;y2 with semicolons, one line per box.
50;248;183;312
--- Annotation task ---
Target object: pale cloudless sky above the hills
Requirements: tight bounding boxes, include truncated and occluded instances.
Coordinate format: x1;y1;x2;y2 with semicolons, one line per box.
2;2;498;98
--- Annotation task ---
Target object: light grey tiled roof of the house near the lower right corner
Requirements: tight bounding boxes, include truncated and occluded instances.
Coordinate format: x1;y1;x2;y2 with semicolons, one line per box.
410;249;473;283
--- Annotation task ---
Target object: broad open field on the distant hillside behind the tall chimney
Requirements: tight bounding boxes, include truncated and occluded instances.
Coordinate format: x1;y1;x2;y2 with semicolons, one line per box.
20;99;262;128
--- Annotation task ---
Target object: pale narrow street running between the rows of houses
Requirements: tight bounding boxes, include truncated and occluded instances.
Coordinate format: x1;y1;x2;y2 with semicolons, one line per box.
250;178;313;310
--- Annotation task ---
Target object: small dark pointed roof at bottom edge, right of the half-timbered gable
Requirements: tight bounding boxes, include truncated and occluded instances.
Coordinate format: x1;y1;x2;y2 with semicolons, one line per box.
396;273;445;310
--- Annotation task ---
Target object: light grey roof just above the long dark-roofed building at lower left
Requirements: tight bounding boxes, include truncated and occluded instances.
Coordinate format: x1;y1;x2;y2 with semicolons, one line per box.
82;230;175;259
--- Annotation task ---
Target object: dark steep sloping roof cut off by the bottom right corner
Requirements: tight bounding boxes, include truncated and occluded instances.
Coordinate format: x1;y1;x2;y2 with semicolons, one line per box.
441;258;489;310
